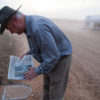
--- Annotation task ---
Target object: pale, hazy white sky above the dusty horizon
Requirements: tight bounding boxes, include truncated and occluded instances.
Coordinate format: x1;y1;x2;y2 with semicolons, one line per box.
0;0;100;20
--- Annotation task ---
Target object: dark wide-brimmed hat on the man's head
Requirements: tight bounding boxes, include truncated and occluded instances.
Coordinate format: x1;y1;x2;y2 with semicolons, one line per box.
0;5;22;35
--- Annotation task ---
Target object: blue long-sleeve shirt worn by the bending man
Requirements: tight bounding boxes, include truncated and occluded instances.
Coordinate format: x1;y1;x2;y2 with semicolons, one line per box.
26;15;72;74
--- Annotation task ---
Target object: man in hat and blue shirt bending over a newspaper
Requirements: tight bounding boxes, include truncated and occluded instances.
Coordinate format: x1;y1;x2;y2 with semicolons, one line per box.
0;6;72;100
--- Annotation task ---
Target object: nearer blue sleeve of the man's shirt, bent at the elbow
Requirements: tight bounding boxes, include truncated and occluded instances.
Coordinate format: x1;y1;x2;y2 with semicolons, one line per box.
35;29;60;74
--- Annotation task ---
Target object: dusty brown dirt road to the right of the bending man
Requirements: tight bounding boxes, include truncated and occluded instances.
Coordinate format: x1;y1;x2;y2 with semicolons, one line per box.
54;21;100;100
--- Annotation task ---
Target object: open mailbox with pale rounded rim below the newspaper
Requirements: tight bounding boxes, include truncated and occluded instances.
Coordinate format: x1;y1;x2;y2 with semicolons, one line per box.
1;85;32;100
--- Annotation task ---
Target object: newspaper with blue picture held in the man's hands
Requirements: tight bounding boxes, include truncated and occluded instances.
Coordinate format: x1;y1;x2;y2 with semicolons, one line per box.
8;55;33;80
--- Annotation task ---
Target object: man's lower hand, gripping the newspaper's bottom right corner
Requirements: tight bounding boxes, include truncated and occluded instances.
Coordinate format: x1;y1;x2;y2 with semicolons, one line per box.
24;67;37;81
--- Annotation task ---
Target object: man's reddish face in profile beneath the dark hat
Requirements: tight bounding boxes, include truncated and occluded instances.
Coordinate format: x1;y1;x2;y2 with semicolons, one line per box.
6;17;25;35
